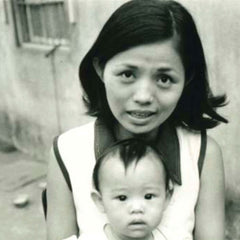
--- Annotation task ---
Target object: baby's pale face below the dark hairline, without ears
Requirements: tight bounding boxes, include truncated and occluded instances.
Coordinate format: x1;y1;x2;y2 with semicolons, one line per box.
99;153;166;239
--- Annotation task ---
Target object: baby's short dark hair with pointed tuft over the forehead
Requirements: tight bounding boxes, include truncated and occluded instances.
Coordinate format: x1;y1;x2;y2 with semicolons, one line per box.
93;138;169;191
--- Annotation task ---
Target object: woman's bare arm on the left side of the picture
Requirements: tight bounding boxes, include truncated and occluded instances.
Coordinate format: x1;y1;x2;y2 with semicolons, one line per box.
47;150;78;240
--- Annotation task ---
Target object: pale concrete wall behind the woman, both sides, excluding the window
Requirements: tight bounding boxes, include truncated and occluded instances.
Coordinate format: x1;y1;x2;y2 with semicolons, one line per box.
0;0;240;199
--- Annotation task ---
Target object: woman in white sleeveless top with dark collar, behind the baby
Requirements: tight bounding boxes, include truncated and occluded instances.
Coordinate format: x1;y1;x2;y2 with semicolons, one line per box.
47;0;227;240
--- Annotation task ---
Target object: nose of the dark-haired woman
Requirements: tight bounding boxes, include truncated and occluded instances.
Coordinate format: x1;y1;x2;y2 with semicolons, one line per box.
133;79;154;105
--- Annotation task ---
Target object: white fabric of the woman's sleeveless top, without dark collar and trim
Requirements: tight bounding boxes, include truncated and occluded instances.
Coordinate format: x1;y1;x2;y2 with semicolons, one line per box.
57;121;204;240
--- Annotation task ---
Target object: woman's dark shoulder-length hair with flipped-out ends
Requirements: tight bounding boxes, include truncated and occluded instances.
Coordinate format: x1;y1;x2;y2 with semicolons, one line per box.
79;0;227;130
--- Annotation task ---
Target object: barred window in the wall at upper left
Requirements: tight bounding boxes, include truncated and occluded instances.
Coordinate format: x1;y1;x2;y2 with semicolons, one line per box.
14;0;69;45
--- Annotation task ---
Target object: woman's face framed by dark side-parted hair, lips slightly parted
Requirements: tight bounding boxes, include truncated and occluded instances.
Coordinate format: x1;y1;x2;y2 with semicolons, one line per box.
102;39;185;139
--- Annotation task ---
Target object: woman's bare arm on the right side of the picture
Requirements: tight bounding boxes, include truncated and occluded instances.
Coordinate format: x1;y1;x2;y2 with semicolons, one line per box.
194;137;225;240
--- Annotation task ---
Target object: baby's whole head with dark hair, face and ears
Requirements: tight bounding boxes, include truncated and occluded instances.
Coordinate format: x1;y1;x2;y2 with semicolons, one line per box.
92;139;168;239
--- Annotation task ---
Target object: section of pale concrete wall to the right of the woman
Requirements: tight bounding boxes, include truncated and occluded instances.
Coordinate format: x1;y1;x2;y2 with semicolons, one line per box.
180;0;240;200
